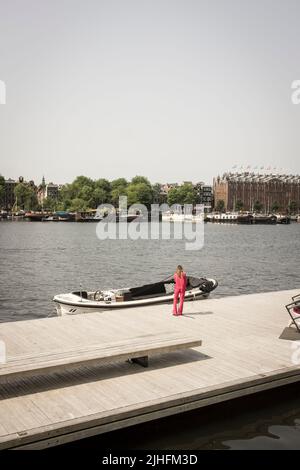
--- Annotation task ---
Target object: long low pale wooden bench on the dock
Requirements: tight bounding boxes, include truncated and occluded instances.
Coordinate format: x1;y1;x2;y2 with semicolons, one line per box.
0;333;202;384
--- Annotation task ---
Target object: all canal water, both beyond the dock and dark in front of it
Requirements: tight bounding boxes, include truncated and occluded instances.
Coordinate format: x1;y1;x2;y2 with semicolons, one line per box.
0;221;300;449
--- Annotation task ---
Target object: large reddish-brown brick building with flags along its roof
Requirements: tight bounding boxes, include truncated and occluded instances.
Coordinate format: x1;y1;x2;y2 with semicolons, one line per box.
213;173;300;213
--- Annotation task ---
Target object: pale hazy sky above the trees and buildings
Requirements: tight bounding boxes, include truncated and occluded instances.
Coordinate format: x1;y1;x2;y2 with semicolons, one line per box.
0;0;300;183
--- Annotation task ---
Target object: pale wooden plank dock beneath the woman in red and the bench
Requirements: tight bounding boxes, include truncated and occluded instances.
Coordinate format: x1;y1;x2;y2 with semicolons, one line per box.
0;290;300;449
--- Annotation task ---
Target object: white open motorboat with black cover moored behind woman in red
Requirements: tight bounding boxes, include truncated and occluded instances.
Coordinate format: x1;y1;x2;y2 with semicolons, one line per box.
53;276;218;315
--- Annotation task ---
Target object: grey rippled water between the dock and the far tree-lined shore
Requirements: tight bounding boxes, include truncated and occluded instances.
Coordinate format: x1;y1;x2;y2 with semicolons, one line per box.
0;221;300;322
